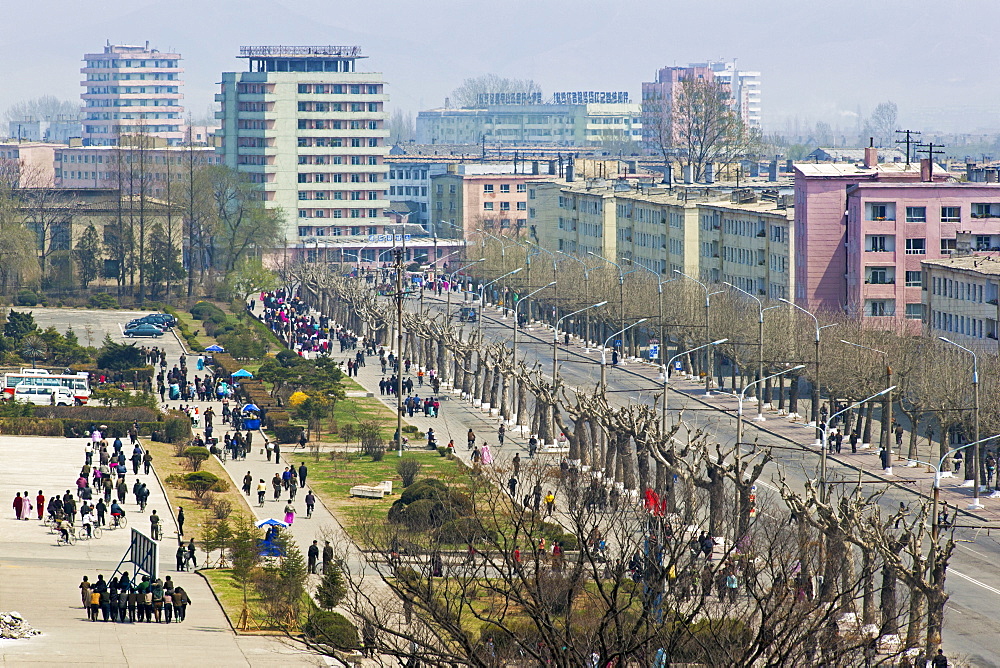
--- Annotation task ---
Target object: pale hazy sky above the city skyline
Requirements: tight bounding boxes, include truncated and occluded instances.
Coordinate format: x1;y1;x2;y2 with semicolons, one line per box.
7;0;1000;132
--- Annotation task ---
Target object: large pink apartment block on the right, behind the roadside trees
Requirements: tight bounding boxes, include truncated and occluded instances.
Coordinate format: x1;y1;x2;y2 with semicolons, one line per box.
795;149;1000;325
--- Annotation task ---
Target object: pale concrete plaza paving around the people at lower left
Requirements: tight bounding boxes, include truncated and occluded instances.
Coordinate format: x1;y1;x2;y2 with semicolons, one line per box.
0;436;317;666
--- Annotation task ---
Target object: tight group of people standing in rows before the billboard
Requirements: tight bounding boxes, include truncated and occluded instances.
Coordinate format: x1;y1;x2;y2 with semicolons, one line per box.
79;573;191;624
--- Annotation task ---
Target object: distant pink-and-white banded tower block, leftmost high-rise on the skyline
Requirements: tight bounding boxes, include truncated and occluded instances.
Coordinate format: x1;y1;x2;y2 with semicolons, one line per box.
80;42;184;146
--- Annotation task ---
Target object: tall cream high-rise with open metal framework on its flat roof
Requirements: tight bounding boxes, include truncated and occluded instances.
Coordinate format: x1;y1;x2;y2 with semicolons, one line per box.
216;46;389;248
